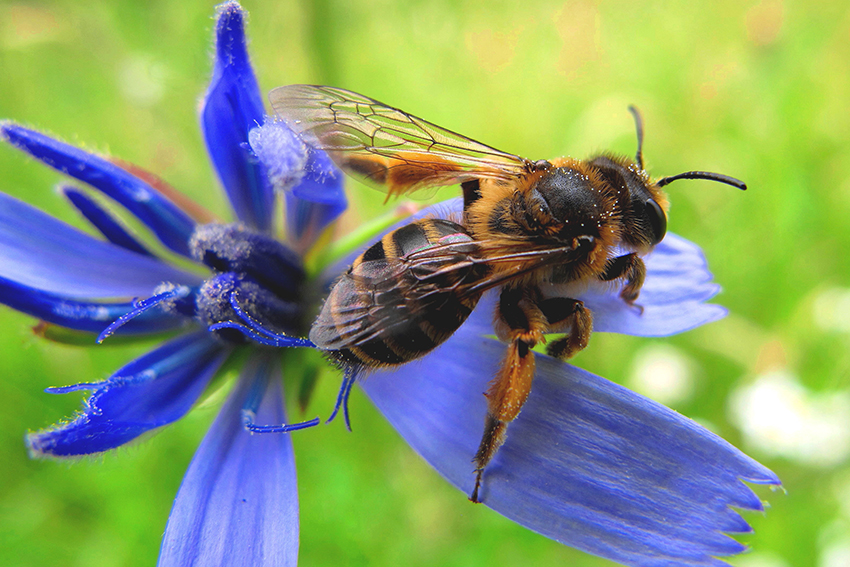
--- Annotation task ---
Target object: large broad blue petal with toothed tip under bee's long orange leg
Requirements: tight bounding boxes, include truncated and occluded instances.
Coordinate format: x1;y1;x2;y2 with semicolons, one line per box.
362;329;779;567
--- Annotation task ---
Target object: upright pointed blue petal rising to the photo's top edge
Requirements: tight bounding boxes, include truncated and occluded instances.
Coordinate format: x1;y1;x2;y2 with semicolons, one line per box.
201;2;274;231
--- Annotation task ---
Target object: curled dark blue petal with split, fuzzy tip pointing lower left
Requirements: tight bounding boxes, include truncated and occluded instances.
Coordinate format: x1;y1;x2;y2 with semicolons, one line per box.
27;331;228;457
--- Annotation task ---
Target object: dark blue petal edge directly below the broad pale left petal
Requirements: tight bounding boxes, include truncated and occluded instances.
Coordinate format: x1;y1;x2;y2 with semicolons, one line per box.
0;277;186;336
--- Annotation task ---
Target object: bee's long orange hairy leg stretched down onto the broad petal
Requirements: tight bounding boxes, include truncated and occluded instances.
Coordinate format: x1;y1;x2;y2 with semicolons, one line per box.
469;288;547;502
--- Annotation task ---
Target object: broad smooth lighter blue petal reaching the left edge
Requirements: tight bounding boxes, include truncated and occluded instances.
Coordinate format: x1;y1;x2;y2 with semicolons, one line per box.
0;193;200;298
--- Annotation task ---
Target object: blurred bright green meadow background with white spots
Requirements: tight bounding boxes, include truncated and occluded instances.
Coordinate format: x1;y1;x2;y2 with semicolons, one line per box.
0;0;850;567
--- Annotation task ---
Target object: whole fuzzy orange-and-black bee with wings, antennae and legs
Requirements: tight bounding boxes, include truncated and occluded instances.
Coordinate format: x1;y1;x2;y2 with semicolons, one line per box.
269;85;746;502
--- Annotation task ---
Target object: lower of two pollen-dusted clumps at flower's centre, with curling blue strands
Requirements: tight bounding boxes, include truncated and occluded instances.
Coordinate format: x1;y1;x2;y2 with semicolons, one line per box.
197;272;309;346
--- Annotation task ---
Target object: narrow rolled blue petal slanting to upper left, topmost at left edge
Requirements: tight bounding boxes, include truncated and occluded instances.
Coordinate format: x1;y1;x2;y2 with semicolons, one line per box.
0;122;195;256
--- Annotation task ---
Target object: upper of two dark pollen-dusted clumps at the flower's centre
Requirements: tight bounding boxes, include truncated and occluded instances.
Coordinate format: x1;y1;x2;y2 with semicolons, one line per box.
190;224;304;300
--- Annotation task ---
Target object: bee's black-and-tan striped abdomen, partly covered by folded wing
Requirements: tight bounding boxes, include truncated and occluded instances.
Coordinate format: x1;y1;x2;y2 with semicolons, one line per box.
310;219;487;368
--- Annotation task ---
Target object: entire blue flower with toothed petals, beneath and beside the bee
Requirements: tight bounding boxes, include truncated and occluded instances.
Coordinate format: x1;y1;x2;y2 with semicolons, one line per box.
0;2;779;566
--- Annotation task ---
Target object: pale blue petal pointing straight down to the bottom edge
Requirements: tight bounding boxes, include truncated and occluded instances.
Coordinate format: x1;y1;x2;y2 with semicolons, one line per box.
159;354;298;567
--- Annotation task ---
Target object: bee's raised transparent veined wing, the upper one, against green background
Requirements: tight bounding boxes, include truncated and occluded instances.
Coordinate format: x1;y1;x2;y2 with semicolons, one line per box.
269;85;532;195
